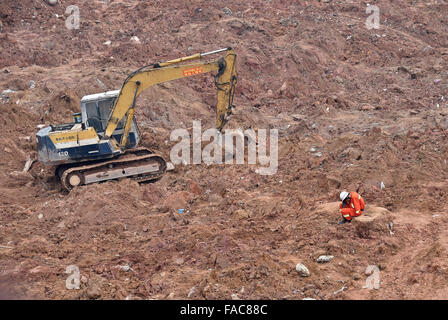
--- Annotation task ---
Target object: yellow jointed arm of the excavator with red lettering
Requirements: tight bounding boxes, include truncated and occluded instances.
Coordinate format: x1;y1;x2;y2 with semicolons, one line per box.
103;48;237;148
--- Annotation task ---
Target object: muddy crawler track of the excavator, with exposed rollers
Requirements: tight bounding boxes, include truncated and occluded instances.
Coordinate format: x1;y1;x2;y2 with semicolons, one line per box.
58;148;167;190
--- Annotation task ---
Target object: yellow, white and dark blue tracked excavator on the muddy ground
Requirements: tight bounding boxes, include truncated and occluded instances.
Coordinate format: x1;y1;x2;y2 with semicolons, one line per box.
36;48;237;190
